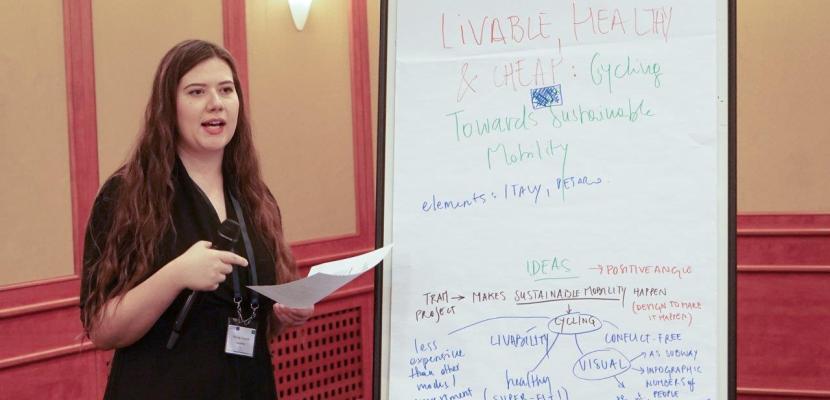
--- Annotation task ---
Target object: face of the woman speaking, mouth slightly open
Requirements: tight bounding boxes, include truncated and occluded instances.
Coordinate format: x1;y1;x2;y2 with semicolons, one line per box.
176;58;239;157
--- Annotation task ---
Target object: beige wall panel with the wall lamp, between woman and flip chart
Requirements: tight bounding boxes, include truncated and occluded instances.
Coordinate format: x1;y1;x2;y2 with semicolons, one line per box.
246;0;356;242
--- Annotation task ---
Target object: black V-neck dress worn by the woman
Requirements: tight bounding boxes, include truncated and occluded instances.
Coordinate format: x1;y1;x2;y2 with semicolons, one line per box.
80;159;276;400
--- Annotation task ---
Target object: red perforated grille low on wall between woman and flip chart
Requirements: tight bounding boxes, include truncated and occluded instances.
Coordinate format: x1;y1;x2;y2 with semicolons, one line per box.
271;308;363;400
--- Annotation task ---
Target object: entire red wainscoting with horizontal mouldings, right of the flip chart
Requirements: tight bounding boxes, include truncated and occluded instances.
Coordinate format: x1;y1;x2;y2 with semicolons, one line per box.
737;215;830;400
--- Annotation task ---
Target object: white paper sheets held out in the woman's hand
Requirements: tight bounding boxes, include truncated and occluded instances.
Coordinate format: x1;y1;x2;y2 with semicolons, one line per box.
248;244;392;308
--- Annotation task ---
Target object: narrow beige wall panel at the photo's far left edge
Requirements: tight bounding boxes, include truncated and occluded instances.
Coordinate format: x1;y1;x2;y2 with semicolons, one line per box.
0;0;74;285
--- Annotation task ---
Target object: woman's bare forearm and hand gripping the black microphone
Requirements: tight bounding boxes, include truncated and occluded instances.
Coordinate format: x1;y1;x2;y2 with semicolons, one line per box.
89;241;248;349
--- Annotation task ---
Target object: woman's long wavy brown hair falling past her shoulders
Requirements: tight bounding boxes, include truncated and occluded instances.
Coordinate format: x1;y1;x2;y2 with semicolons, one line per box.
81;40;297;332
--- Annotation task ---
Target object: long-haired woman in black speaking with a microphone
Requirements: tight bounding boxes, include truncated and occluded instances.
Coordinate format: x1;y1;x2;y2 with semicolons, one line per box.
81;40;313;399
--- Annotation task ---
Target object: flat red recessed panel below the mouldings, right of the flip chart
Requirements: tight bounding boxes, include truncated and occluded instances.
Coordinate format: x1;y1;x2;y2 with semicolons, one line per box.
737;272;830;390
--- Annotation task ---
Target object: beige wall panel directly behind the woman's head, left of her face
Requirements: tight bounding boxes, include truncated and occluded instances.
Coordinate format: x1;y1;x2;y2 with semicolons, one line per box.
92;0;223;183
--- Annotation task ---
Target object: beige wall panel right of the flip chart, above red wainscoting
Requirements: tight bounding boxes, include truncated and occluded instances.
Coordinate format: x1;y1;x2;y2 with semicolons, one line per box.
737;0;830;213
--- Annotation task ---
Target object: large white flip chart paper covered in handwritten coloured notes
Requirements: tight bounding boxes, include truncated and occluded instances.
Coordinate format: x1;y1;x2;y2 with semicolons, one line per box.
382;0;728;400
